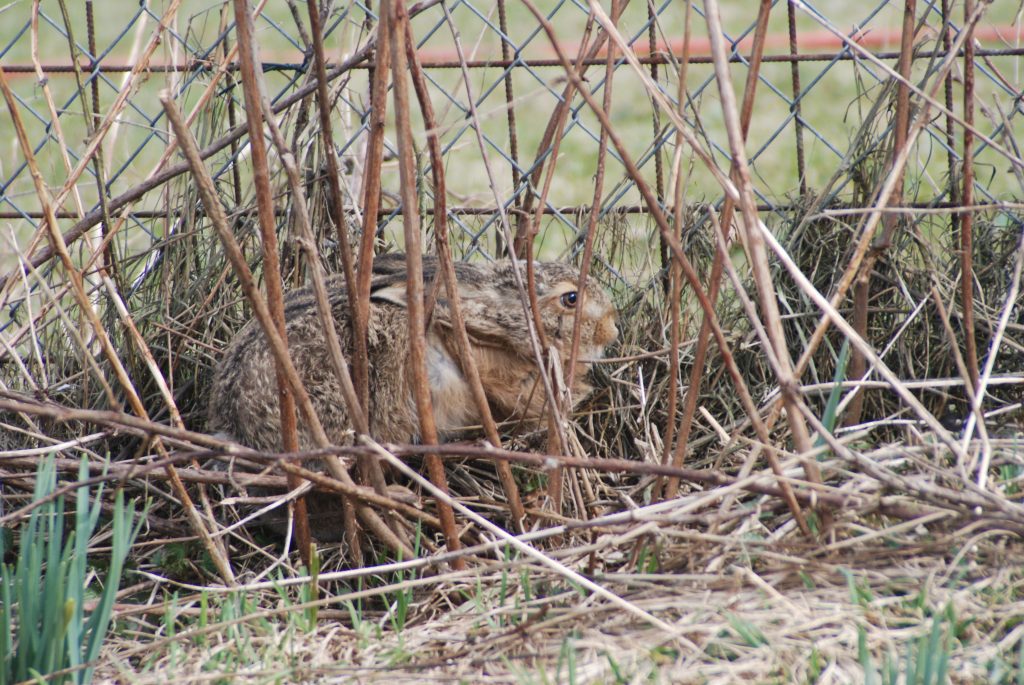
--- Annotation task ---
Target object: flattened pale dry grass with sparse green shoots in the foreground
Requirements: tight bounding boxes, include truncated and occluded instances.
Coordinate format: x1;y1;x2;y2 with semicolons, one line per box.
88;494;1021;683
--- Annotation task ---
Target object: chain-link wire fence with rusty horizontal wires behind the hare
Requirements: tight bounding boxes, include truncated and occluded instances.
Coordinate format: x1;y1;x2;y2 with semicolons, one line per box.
0;0;1024;374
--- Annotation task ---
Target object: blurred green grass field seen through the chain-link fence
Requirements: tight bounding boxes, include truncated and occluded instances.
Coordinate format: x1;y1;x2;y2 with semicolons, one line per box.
0;1;1020;269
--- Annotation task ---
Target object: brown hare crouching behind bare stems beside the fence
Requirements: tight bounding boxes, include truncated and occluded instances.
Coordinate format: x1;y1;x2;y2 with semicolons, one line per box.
208;254;618;451
